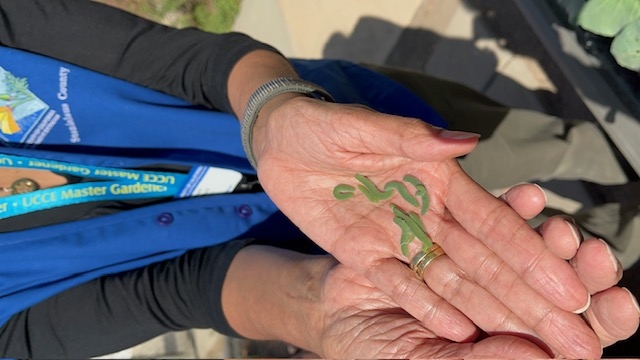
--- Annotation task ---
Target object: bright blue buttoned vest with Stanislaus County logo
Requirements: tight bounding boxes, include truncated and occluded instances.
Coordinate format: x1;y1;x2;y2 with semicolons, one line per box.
0;47;445;325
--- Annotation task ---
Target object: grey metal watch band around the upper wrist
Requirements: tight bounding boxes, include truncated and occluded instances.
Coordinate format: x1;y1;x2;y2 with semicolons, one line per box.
240;78;333;170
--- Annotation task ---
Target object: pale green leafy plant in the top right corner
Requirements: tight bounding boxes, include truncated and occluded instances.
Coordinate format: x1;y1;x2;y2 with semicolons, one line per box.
577;0;640;71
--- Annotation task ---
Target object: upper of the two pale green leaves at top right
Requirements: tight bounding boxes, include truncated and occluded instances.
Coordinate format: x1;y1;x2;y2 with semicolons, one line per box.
578;0;640;37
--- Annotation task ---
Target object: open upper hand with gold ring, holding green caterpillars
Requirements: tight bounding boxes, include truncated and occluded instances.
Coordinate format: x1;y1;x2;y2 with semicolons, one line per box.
253;97;601;358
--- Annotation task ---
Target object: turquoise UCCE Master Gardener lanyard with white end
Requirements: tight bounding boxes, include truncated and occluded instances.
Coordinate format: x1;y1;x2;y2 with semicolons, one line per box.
0;154;242;219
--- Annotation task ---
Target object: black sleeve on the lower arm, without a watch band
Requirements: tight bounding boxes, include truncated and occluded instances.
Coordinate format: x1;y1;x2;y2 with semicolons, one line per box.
0;240;248;358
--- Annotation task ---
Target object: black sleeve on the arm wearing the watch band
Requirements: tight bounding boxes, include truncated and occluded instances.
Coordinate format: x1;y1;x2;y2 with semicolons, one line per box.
0;0;286;112
